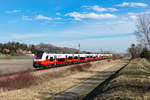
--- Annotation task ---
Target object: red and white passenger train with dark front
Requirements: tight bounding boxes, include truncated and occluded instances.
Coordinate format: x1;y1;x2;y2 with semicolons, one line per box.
33;51;112;68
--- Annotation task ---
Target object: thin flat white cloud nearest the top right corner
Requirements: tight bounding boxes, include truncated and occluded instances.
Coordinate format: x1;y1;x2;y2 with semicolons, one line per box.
117;2;148;7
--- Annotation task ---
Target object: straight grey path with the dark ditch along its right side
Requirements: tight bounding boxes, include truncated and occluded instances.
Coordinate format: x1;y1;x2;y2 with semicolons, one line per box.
49;60;129;100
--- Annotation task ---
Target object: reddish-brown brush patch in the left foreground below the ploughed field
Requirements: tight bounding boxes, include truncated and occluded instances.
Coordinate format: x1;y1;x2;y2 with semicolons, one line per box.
0;71;38;90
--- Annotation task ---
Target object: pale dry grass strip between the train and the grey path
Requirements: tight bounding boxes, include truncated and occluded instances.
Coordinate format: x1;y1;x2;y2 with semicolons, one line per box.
0;60;120;100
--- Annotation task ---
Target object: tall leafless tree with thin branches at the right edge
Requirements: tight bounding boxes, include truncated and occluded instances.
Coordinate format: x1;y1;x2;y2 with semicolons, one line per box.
136;15;150;46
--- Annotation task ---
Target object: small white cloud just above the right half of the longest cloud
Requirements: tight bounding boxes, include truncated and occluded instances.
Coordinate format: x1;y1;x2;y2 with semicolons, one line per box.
91;5;118;12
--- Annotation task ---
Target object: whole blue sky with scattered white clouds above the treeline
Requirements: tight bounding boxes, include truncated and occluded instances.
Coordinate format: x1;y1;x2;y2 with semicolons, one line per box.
0;0;150;52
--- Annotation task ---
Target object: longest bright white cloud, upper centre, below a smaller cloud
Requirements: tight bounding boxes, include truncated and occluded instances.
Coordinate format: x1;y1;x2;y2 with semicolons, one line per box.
65;12;117;20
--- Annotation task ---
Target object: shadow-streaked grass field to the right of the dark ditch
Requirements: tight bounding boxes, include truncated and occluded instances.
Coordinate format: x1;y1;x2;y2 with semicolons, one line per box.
94;58;150;100
